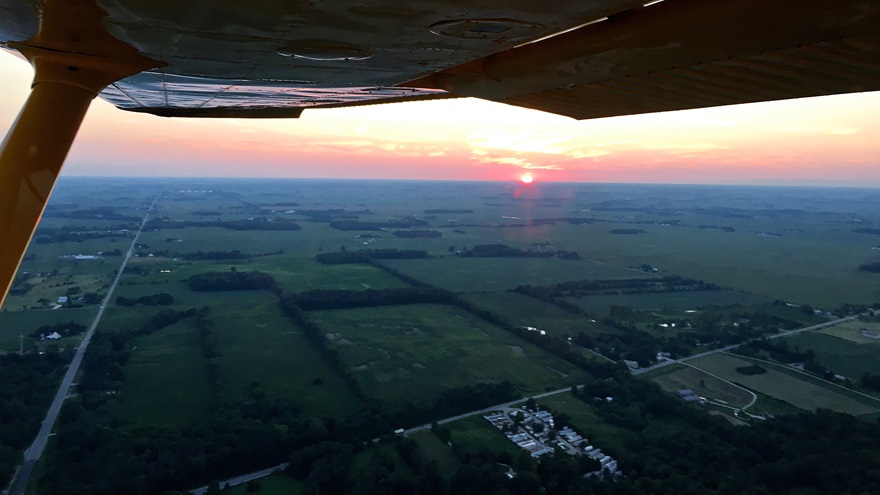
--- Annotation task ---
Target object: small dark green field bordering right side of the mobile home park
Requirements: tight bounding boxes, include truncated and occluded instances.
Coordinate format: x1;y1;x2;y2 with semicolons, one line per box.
538;392;633;452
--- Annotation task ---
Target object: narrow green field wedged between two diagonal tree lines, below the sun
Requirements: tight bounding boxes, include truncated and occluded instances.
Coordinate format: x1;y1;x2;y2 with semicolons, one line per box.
463;292;619;335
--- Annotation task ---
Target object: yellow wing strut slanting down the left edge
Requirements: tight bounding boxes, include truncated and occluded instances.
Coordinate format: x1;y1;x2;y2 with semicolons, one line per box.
0;0;163;307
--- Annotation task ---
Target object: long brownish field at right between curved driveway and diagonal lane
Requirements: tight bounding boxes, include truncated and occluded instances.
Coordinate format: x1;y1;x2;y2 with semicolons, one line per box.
690;354;880;416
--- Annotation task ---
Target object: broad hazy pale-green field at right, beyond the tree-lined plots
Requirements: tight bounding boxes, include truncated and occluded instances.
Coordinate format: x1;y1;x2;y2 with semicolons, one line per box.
550;223;880;308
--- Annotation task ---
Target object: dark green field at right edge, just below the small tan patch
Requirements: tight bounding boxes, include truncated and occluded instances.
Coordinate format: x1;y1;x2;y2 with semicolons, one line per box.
785;331;880;381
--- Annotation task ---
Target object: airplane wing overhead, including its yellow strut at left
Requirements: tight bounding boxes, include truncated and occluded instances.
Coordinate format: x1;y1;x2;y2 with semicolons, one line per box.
0;0;880;303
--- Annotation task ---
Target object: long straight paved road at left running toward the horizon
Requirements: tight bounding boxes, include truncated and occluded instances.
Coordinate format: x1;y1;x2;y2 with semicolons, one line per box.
9;194;161;495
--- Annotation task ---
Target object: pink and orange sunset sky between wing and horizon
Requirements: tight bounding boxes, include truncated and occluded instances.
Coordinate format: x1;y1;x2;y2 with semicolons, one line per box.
0;51;880;187
